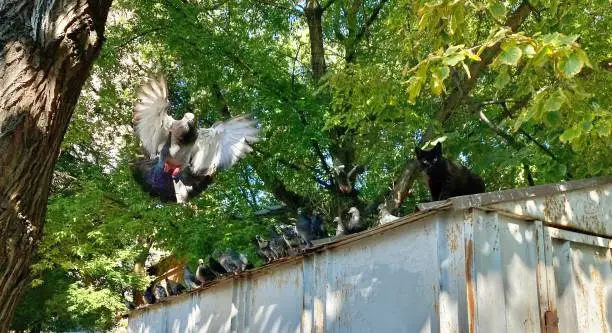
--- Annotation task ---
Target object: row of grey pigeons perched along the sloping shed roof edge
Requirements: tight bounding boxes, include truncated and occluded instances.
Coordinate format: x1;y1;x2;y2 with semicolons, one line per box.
124;206;398;309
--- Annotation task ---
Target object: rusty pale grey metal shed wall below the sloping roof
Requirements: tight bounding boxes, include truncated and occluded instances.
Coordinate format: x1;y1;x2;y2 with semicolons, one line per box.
129;179;612;333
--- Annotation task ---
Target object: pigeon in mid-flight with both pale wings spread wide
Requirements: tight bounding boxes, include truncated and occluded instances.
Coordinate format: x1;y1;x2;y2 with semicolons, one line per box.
133;77;259;203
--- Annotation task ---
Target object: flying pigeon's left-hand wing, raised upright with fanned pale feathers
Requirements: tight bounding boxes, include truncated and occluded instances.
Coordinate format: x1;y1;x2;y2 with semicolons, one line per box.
133;77;174;158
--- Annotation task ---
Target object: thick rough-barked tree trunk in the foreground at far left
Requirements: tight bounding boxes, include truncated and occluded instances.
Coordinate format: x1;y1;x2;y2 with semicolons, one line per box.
0;0;112;333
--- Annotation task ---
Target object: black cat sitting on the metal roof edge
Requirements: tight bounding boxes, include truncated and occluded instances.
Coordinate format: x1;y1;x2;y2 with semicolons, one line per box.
414;142;485;201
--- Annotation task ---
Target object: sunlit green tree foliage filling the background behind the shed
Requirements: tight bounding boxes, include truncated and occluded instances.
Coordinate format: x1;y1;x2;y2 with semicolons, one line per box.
14;0;612;330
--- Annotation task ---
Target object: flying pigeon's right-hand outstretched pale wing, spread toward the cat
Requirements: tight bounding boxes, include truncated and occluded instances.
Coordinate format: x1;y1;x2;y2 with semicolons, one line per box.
191;116;259;175
